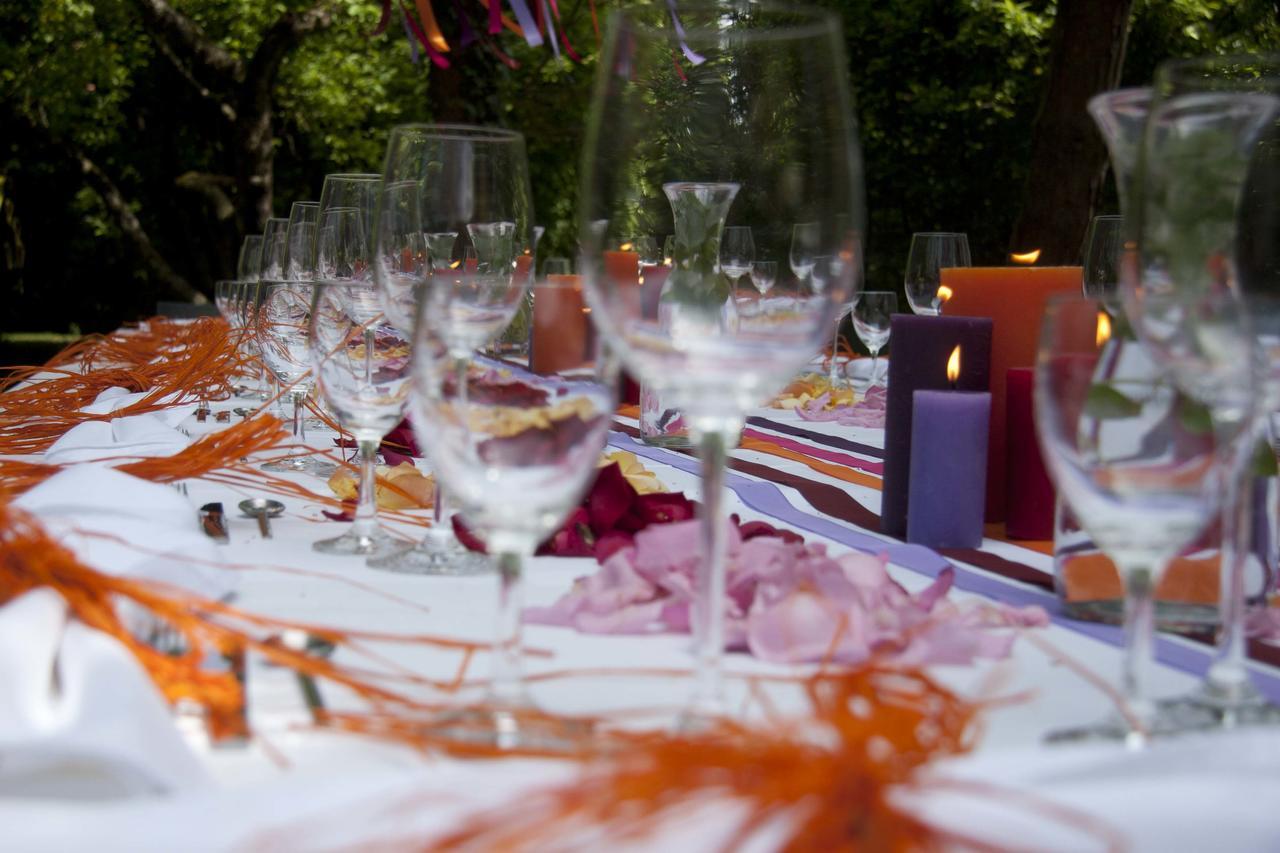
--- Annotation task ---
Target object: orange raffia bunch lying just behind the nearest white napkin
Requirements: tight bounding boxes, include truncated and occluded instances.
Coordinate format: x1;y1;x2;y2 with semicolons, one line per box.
0;502;485;719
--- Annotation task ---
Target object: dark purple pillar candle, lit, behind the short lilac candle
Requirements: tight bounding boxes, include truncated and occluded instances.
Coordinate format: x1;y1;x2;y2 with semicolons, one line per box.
881;314;992;539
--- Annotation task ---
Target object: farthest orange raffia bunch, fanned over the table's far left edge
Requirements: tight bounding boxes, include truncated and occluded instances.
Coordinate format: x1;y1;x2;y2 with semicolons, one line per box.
0;318;244;455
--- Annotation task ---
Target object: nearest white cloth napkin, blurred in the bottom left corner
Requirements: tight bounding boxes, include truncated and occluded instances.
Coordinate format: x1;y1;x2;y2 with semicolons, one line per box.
0;588;211;799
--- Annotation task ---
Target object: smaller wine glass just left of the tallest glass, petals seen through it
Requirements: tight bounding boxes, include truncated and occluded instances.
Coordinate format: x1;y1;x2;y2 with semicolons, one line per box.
412;280;617;748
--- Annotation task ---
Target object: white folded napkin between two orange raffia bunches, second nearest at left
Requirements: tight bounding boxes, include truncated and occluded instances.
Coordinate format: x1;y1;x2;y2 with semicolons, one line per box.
14;465;238;598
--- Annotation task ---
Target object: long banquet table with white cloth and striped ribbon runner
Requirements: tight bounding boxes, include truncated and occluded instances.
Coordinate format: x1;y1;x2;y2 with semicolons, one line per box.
0;340;1280;850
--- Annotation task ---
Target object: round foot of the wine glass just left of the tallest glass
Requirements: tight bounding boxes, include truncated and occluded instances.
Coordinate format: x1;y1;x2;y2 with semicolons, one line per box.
430;702;591;754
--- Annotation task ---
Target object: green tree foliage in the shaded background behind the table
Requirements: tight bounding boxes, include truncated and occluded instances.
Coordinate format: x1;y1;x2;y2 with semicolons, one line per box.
0;0;1280;338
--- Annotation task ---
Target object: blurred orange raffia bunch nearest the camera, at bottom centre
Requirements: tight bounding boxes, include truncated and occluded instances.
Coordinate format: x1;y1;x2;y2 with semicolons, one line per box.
434;663;978;850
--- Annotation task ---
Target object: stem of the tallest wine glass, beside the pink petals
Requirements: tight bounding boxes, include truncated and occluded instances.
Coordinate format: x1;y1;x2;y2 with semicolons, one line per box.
690;419;741;717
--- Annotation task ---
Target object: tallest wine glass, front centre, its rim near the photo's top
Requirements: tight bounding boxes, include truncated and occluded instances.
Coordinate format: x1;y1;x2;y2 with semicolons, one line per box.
579;3;863;726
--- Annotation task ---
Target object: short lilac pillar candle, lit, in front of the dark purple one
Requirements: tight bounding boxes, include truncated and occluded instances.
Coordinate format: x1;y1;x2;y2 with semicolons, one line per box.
906;391;991;548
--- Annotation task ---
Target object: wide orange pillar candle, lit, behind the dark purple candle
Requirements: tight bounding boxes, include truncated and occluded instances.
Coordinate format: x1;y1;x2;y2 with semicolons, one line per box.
942;266;1083;523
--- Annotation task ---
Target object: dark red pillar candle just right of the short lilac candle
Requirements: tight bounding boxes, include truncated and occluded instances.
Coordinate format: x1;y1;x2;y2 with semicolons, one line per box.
1005;368;1055;539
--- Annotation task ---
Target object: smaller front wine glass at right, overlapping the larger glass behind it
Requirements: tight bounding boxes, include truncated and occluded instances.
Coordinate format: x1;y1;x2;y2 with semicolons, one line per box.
1034;297;1249;747
